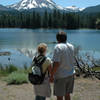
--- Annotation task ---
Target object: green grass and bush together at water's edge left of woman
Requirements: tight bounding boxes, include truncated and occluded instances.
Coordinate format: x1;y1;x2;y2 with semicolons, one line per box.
0;65;30;84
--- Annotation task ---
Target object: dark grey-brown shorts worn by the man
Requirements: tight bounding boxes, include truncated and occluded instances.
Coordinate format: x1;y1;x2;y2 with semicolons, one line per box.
54;75;74;96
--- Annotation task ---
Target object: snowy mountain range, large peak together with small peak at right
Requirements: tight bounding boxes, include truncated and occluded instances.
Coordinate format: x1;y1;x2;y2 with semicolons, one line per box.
8;0;84;12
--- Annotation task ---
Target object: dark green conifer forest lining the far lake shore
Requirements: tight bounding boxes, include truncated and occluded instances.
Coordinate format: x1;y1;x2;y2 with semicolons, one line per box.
0;10;100;29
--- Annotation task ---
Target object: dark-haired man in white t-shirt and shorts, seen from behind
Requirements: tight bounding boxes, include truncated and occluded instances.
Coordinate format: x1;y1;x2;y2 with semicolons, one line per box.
50;32;74;100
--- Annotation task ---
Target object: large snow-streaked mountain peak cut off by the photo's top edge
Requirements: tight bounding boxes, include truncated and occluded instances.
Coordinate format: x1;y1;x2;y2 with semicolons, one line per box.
8;0;63;10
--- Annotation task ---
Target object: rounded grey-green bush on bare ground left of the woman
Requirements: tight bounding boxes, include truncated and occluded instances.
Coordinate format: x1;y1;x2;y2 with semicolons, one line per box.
5;71;28;84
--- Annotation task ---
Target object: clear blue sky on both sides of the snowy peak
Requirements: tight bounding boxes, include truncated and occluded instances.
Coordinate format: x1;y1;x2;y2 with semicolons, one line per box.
0;0;100;8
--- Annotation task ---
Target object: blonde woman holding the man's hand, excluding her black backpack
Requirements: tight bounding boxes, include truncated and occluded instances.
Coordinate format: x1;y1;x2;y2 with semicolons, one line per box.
34;43;51;100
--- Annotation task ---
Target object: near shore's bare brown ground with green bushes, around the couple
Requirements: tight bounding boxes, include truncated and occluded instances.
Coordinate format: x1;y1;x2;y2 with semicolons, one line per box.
0;65;100;100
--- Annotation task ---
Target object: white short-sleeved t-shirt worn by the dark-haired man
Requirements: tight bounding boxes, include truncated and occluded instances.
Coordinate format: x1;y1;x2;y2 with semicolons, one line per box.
53;43;74;79
